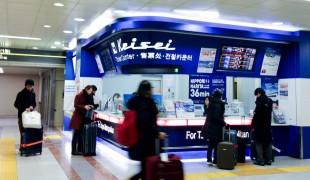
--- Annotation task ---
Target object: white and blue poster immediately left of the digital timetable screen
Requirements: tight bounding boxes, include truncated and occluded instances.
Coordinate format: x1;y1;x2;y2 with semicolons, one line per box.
197;48;216;73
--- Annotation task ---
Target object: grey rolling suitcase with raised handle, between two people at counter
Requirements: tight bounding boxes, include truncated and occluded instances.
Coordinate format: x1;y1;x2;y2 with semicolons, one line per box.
217;128;236;170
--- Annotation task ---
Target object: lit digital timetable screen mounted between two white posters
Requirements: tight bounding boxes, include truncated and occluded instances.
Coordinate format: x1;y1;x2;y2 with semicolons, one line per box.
217;45;258;71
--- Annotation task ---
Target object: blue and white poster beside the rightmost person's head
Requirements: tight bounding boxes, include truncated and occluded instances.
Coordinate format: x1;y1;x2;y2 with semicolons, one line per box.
261;77;279;104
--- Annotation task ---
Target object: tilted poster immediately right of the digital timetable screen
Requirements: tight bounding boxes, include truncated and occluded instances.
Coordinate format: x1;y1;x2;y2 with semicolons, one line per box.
260;48;281;76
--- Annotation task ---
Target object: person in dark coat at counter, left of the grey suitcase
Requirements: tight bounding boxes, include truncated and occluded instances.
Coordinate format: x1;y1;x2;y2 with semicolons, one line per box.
206;90;226;164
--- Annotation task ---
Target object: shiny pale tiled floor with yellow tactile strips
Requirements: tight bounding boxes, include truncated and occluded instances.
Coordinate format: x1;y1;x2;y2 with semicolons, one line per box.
0;117;310;180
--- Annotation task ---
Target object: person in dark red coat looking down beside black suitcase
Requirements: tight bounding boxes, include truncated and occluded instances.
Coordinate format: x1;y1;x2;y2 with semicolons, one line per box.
69;85;94;155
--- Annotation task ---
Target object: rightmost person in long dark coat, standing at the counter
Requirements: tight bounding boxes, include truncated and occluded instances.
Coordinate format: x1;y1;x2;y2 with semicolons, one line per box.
251;88;272;166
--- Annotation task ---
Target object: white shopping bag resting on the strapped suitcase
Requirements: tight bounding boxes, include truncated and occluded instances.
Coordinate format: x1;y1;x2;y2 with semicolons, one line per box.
22;111;41;129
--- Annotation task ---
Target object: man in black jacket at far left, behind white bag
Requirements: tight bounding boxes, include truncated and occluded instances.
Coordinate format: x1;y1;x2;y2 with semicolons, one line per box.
14;79;37;136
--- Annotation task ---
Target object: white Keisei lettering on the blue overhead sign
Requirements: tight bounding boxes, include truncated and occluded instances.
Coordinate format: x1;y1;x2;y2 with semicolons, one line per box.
111;38;176;54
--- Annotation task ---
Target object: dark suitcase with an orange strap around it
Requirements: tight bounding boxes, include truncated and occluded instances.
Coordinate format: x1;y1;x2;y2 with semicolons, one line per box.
19;127;43;156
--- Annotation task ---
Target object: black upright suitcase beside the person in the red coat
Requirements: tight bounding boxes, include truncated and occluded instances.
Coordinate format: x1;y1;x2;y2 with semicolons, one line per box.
82;123;97;156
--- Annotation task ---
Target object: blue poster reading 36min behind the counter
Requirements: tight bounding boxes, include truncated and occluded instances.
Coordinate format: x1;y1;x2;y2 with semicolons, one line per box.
189;75;226;104
